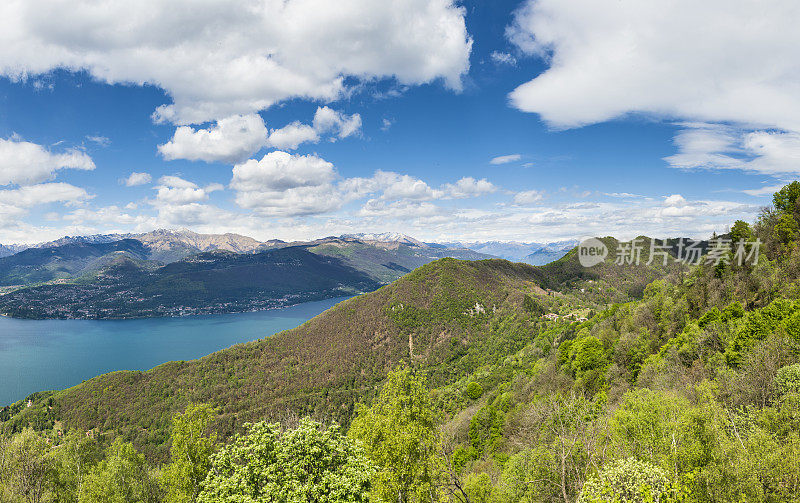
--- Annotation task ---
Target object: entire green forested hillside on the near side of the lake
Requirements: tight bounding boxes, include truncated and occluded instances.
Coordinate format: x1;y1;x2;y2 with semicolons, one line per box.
0;182;800;503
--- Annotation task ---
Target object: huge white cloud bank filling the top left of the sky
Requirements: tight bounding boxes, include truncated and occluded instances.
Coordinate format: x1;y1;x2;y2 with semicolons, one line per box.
0;0;472;124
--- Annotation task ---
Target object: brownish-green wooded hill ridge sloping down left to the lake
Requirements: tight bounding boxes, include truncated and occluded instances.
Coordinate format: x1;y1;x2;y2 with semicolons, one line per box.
5;248;676;458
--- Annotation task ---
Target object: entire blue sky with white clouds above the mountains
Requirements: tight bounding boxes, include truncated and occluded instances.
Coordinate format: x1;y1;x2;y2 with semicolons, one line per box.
0;0;800;243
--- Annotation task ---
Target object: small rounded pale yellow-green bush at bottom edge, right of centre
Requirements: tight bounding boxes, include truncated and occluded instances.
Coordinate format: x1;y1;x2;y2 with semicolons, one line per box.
578;458;670;503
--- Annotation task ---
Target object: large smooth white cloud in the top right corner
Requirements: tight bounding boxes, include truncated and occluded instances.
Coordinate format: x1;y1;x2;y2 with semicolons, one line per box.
507;0;800;131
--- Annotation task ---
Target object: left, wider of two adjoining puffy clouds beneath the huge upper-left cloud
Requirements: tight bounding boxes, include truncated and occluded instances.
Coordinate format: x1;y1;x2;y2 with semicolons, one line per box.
158;113;267;163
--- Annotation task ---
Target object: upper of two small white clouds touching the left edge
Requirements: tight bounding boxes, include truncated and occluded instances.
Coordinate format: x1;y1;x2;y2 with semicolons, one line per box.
0;137;95;186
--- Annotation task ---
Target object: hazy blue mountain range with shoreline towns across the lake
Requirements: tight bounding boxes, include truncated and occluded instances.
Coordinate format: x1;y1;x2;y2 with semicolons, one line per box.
0;230;493;319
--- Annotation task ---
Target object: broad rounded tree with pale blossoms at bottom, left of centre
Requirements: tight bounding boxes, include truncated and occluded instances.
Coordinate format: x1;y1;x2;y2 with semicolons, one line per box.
197;418;374;503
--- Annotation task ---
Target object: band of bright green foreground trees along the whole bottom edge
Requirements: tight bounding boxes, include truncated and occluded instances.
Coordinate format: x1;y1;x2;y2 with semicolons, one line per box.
0;358;800;503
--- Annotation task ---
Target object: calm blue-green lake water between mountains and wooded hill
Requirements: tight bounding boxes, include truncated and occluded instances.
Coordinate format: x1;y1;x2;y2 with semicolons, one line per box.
0;297;346;407
